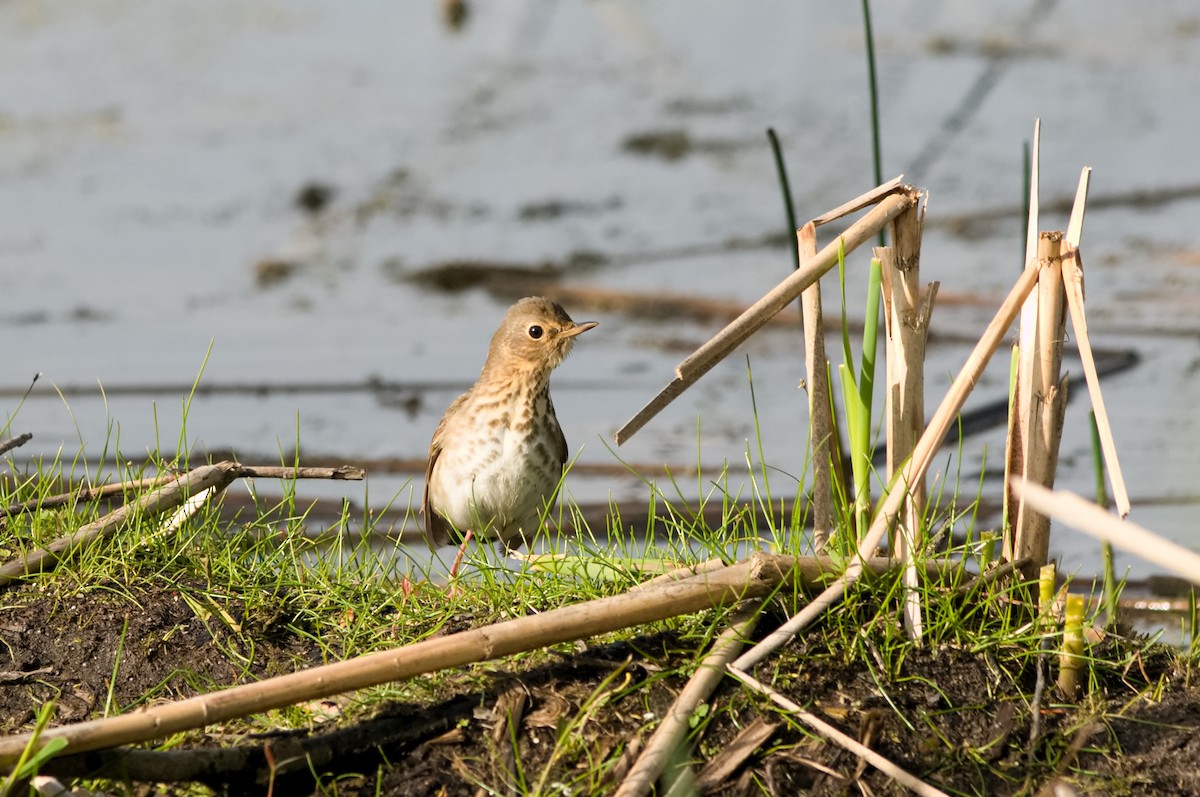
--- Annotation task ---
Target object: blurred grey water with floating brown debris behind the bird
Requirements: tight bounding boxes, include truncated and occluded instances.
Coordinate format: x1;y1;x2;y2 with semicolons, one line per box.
0;0;1200;576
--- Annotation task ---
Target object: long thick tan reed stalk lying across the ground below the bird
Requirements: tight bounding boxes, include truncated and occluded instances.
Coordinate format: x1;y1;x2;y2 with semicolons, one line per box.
0;554;798;768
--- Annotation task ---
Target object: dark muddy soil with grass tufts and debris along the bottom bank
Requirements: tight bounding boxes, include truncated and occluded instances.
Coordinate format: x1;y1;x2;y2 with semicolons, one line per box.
0;586;1200;796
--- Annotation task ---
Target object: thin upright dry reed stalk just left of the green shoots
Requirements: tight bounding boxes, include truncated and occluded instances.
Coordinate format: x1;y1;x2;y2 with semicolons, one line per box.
796;222;834;552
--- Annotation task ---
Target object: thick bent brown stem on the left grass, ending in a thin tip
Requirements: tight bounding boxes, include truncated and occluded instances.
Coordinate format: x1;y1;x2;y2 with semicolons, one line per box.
0;461;364;587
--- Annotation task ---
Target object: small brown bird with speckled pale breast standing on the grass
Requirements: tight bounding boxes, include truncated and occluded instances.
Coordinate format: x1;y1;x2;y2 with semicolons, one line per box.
422;296;596;575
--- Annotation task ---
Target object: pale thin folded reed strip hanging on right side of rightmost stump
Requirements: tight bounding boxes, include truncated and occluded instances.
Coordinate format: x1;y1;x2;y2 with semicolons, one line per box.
1062;167;1129;517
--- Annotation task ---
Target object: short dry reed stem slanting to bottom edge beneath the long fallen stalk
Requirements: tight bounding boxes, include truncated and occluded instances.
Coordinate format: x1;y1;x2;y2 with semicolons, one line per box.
614;606;758;797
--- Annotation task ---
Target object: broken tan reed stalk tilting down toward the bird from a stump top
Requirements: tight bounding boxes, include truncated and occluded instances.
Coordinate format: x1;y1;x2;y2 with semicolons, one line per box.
614;188;916;445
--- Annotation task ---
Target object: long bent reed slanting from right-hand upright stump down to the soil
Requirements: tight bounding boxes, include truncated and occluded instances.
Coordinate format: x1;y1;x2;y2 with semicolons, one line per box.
731;262;1038;670
